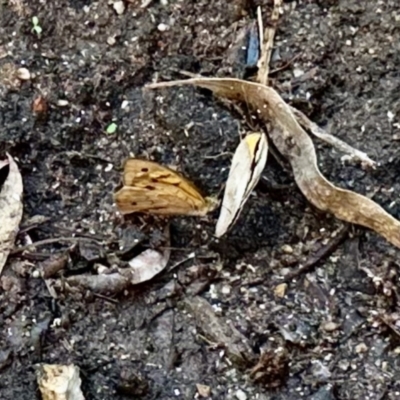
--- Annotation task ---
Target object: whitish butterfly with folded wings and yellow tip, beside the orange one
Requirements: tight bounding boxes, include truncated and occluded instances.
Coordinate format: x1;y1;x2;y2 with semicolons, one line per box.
215;133;268;237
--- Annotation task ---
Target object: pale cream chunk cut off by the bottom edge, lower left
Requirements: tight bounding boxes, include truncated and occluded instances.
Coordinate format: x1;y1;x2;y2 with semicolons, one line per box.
37;364;85;400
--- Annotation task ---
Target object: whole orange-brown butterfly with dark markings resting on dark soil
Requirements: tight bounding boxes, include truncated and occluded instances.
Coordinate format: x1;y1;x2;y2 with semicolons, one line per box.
114;158;218;216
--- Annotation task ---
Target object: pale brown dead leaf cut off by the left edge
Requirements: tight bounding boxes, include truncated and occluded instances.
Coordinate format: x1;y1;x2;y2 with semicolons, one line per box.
0;154;23;274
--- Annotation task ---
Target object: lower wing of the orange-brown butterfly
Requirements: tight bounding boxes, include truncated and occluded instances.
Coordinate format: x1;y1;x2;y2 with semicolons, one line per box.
114;182;209;216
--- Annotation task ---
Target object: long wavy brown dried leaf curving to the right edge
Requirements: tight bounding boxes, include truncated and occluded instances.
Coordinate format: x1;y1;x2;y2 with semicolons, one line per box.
147;78;400;248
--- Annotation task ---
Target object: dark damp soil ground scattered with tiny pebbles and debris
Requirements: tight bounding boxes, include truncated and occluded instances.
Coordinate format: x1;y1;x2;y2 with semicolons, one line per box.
0;0;400;400
